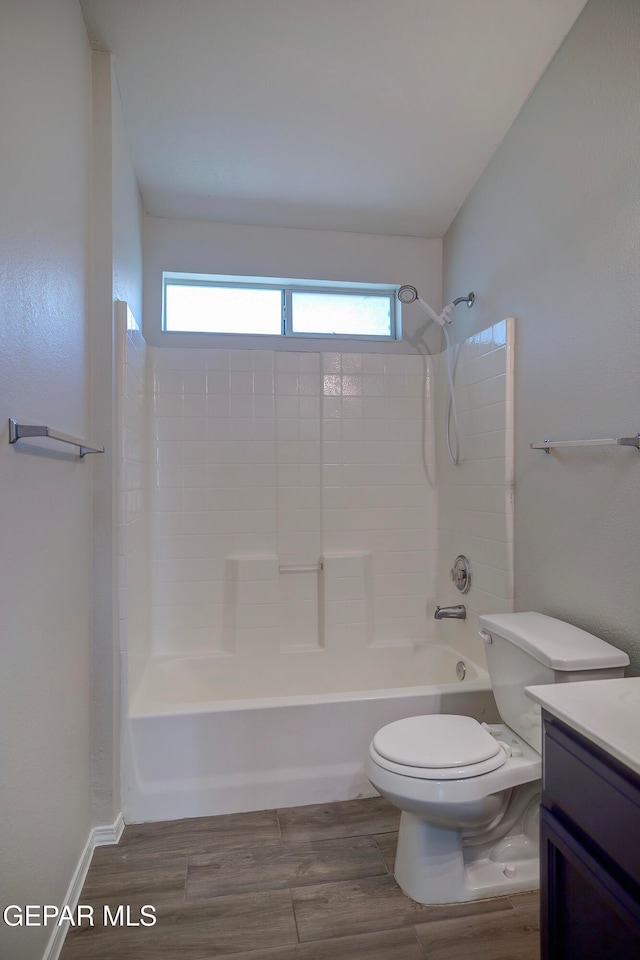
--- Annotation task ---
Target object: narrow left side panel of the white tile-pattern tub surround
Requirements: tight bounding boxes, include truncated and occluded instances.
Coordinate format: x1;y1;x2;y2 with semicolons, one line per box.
116;302;151;694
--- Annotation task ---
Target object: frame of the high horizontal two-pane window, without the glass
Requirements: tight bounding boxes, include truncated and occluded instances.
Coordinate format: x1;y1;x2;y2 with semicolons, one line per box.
161;271;402;343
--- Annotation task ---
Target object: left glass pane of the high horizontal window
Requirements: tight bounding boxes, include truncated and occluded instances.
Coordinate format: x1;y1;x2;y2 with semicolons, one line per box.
165;283;282;335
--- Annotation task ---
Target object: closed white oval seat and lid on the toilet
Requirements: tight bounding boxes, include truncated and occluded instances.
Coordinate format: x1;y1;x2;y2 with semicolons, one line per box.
370;714;507;780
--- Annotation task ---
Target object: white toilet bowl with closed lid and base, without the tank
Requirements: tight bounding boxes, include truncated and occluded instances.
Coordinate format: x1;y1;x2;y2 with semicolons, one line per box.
365;715;541;903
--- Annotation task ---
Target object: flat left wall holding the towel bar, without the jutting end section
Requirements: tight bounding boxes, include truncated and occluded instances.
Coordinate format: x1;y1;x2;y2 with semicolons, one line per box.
0;0;94;960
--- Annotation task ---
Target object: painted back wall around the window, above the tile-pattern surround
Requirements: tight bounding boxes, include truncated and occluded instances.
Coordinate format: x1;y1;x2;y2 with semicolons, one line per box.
144;217;442;353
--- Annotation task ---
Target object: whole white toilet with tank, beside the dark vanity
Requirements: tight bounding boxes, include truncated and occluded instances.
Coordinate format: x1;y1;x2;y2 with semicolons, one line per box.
365;612;629;903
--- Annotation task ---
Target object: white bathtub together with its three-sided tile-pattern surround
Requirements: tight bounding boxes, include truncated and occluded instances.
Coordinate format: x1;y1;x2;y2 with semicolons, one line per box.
119;314;512;822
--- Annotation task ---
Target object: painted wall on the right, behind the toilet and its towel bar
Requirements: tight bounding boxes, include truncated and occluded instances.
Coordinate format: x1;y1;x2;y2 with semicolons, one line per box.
444;0;640;674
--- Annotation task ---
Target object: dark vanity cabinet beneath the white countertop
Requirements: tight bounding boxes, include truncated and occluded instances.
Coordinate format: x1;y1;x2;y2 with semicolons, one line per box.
540;710;640;960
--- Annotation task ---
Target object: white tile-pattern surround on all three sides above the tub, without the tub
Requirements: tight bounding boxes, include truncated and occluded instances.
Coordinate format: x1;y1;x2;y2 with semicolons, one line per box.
121;318;513;664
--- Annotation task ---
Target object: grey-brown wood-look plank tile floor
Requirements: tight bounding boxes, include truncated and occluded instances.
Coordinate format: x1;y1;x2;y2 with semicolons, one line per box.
60;798;539;960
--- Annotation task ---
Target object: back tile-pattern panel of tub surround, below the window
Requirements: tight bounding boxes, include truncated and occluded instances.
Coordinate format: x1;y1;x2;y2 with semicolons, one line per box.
150;348;437;653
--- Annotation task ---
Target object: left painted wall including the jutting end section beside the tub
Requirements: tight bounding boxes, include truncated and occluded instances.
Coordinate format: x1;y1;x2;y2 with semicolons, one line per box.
0;0;142;960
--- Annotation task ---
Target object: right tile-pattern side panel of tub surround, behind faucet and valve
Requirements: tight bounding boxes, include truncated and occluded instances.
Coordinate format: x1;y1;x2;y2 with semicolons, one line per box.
436;318;515;656
